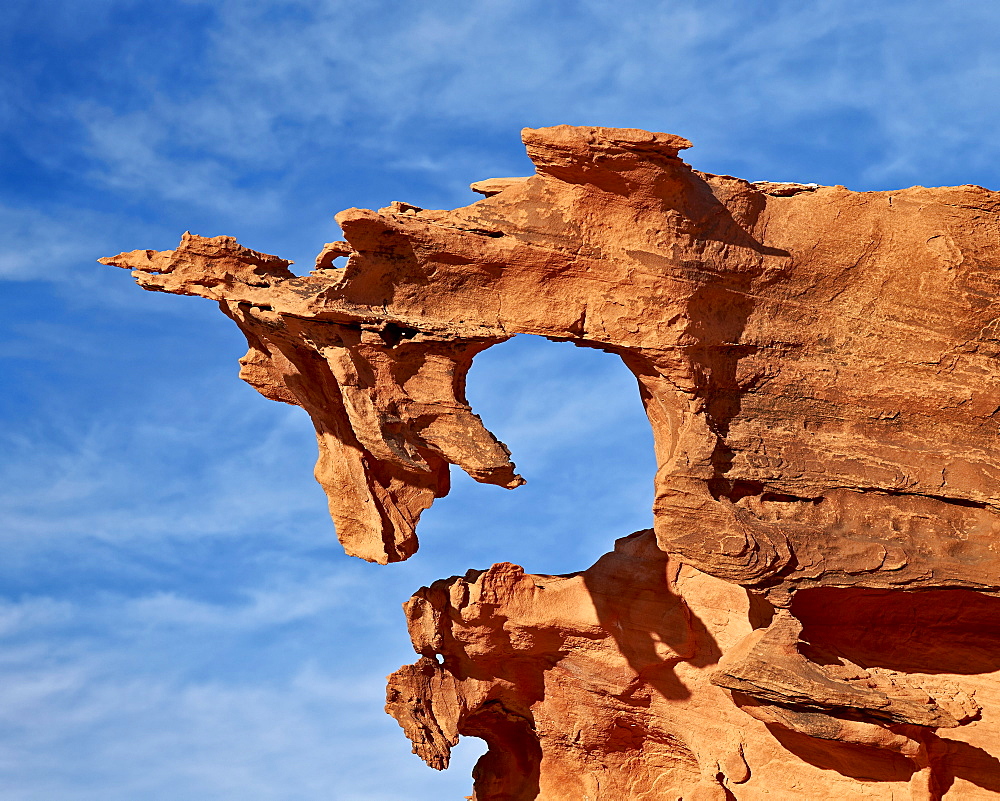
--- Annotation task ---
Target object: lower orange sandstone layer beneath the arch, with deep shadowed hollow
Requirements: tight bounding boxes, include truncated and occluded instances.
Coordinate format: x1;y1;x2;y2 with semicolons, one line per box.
386;531;1000;801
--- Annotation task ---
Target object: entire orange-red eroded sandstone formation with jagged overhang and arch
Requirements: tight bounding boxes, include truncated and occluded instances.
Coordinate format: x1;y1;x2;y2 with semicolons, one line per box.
104;126;1000;801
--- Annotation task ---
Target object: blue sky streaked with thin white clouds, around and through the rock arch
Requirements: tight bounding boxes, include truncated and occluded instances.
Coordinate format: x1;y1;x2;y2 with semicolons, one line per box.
0;0;1000;801
